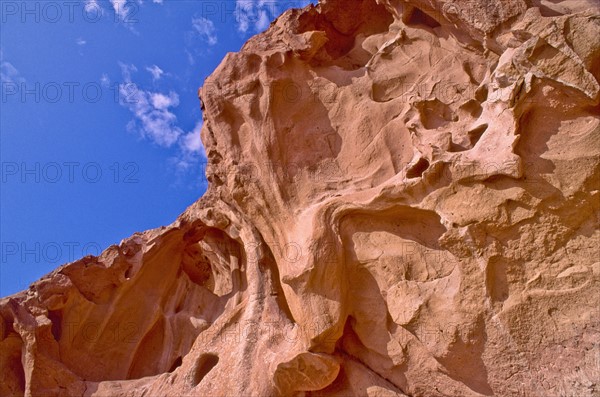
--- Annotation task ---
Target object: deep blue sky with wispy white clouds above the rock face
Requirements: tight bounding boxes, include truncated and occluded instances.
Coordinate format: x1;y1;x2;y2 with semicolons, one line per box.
0;0;309;296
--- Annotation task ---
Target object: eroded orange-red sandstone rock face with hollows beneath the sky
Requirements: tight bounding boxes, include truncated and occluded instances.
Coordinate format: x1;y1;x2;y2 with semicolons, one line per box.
0;0;600;397
